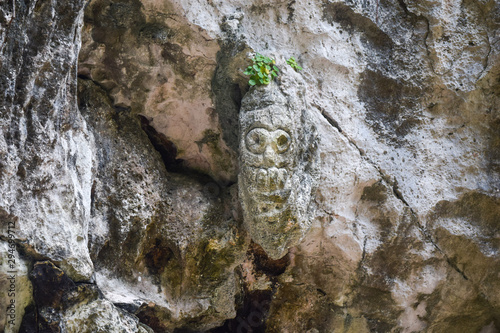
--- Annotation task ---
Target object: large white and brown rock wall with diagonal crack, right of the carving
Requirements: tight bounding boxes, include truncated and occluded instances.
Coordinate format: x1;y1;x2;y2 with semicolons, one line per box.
170;1;499;332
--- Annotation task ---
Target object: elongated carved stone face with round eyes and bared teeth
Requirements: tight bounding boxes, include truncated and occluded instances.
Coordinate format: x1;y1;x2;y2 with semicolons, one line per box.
239;85;311;258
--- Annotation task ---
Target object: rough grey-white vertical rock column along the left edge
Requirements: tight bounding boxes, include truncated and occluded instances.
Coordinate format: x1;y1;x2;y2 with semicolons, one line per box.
0;0;93;281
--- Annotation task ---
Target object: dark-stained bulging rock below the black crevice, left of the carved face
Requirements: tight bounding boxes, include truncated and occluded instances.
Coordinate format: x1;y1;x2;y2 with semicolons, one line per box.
79;80;248;332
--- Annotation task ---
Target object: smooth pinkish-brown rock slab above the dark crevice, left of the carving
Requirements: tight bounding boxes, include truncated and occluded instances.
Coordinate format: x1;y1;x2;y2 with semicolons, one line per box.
78;0;237;184
